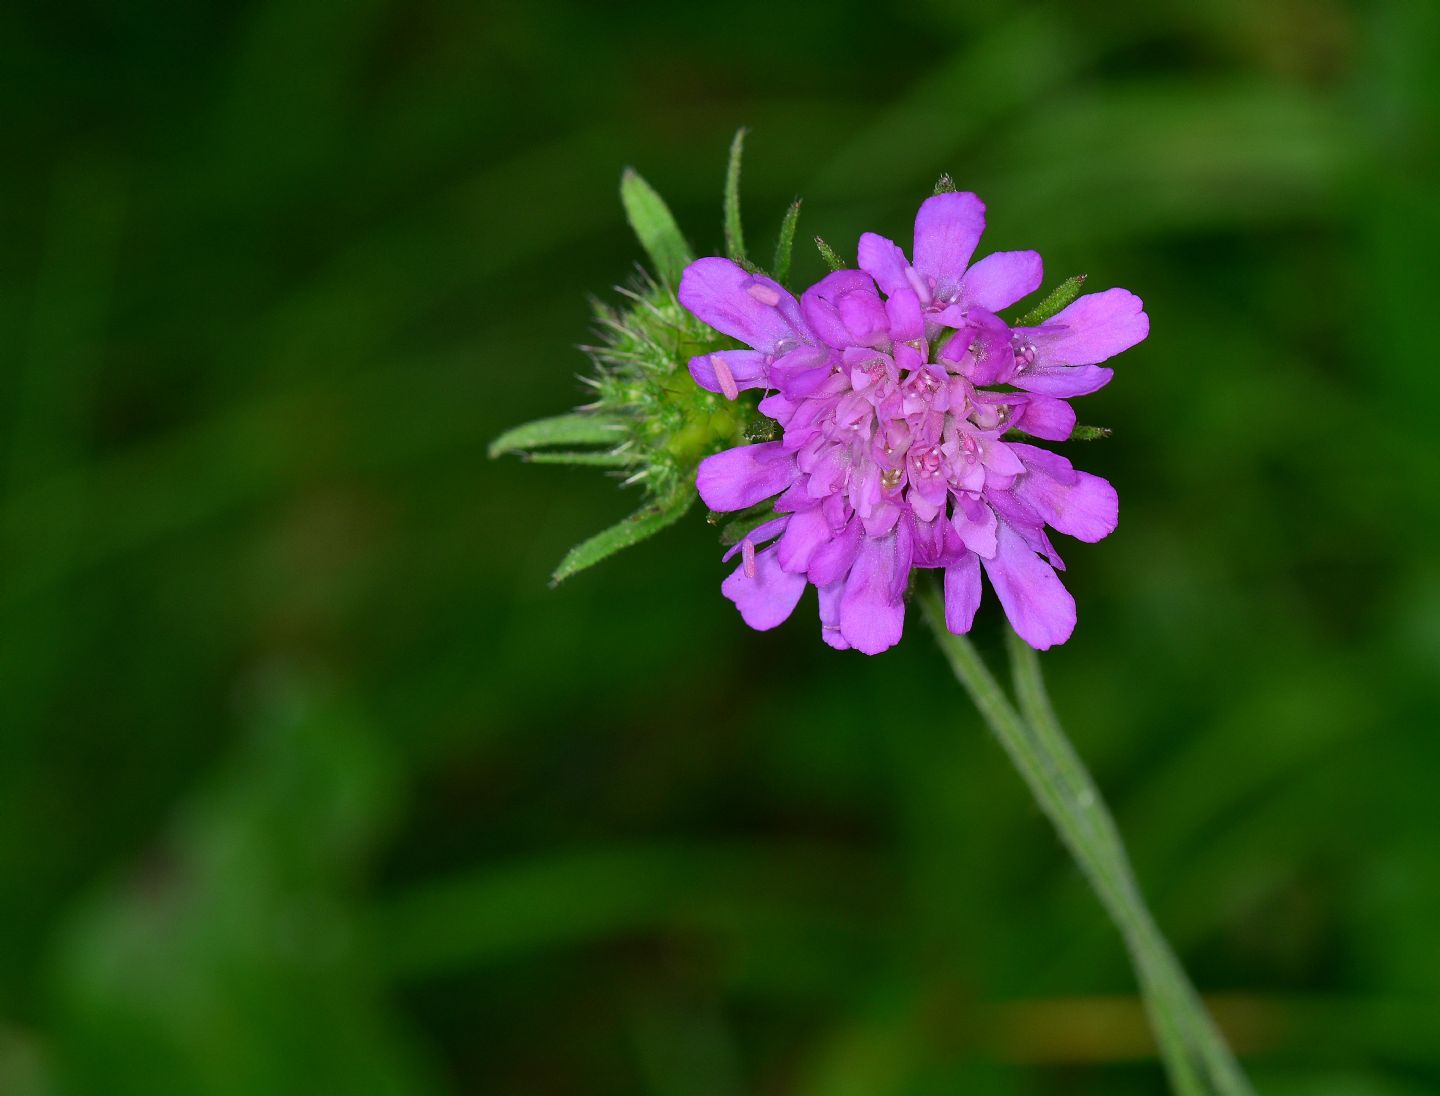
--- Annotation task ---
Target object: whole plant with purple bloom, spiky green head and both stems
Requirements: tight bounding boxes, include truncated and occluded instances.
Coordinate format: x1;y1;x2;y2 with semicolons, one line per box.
491;138;1250;1096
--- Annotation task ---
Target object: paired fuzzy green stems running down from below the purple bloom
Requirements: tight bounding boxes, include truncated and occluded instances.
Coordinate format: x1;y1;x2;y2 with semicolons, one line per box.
920;583;1251;1096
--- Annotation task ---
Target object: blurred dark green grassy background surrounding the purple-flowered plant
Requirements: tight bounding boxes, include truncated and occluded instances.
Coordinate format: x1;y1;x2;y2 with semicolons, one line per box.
0;0;1440;1096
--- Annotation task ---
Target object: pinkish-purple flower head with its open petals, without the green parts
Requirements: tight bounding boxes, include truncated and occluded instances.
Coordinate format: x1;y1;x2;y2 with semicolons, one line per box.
680;193;1149;654
